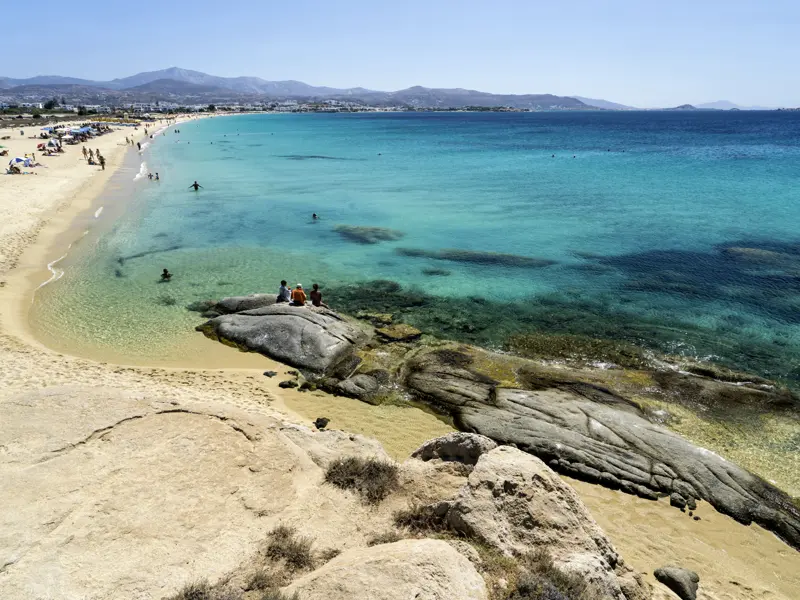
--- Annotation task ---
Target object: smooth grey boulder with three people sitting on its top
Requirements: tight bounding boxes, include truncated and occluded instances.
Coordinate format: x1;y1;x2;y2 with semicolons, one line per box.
197;304;366;374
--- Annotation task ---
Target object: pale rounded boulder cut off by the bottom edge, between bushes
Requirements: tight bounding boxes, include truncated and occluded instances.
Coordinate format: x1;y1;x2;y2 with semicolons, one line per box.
286;540;487;600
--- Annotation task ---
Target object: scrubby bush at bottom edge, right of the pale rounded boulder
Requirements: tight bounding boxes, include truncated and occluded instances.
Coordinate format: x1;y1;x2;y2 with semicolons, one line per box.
509;552;602;600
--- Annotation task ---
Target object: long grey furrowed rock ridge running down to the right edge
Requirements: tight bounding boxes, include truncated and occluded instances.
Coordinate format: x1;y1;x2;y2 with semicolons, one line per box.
406;353;800;549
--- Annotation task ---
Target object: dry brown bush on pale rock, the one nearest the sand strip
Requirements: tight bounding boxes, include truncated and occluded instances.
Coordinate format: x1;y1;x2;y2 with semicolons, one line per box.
325;456;399;504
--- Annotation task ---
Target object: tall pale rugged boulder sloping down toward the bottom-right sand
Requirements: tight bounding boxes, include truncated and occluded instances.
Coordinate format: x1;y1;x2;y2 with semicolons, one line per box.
438;446;650;600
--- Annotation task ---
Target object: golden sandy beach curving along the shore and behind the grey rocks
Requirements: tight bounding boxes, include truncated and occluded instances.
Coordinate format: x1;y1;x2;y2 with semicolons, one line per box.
0;113;800;600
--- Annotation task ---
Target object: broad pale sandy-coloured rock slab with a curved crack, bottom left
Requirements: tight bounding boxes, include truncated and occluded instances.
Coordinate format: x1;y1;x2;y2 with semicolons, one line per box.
0;388;312;600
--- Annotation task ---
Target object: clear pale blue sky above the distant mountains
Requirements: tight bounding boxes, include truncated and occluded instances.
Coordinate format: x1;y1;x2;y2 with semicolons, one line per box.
6;0;800;107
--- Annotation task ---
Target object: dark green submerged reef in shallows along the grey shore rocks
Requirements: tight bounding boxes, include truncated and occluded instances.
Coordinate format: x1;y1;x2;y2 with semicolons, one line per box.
326;280;800;388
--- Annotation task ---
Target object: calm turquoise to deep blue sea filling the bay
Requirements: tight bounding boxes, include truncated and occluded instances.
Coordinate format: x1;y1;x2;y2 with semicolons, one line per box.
29;112;800;380
